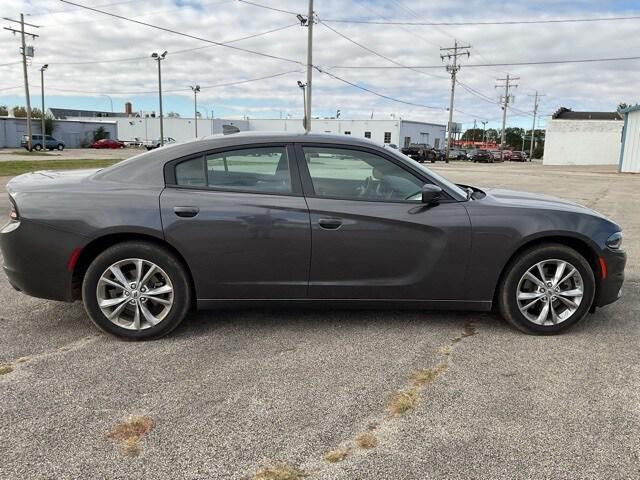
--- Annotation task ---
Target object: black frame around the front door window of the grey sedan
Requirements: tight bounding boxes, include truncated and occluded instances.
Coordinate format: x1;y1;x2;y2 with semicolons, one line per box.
294;142;458;205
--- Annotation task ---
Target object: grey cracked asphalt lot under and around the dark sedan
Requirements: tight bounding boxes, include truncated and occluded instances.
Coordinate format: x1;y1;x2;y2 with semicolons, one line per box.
0;163;640;480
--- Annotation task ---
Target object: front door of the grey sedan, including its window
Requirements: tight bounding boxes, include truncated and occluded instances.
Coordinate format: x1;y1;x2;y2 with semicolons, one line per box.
296;144;471;301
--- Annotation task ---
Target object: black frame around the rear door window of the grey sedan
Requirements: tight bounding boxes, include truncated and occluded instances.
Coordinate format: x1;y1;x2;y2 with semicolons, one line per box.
164;142;303;197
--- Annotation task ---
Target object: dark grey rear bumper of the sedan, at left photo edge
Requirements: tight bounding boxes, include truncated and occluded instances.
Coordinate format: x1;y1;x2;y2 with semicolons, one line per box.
0;220;79;301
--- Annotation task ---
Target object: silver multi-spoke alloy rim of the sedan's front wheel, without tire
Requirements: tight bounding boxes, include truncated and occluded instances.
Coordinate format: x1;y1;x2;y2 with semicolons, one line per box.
516;259;584;325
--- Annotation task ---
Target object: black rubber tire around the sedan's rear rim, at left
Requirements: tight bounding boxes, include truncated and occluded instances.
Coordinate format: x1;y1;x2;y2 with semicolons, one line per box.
82;241;192;340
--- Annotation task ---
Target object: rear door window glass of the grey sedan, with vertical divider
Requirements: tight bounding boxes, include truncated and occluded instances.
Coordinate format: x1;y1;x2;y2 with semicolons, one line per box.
176;147;291;193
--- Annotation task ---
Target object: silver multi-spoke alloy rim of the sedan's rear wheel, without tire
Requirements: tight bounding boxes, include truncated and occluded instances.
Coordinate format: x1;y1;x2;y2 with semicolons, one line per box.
96;258;174;331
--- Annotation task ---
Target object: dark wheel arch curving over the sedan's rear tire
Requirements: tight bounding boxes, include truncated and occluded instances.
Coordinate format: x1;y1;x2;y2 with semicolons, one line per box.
72;232;196;301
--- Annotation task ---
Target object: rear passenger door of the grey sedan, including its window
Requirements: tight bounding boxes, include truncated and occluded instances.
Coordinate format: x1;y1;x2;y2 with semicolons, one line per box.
160;144;311;300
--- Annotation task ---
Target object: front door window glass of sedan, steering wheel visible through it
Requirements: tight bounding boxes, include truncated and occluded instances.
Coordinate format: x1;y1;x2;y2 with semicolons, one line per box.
304;147;424;202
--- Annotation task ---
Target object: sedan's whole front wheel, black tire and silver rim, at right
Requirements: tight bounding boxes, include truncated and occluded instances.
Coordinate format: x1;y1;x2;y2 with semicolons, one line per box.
498;244;595;335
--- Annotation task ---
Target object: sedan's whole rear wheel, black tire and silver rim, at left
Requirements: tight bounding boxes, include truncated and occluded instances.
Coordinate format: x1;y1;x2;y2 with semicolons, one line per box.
82;242;191;340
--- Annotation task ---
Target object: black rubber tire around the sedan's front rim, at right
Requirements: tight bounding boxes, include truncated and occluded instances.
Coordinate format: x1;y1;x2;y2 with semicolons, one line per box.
498;243;595;335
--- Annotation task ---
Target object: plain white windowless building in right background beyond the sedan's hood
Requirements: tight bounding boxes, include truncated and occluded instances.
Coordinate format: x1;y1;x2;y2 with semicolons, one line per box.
543;108;623;165
